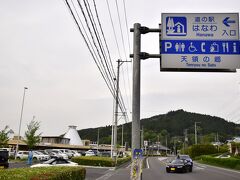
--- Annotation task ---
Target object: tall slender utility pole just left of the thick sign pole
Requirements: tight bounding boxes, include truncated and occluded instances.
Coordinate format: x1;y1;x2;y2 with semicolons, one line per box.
114;59;121;159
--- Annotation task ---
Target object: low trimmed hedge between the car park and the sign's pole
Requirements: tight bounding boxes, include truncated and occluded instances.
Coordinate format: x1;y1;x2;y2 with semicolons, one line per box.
71;156;131;167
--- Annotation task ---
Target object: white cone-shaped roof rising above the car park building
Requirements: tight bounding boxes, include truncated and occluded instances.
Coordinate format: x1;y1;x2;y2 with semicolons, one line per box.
64;126;83;146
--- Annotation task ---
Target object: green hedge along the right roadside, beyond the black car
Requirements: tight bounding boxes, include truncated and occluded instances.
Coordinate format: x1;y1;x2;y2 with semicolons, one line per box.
198;156;240;170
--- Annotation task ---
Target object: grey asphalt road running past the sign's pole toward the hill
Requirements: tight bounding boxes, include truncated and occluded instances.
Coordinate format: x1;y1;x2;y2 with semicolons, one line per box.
93;157;240;180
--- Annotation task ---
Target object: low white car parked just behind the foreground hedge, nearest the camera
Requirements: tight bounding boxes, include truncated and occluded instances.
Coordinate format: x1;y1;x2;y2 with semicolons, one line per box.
31;158;78;168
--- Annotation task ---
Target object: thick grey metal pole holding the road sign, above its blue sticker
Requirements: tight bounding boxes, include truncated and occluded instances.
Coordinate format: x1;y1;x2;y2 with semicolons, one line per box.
132;23;141;156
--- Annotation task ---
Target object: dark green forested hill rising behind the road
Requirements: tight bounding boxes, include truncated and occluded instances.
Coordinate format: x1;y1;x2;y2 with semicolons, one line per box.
78;109;240;145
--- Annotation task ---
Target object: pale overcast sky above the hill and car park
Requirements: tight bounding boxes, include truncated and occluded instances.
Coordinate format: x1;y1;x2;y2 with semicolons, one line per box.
0;0;240;135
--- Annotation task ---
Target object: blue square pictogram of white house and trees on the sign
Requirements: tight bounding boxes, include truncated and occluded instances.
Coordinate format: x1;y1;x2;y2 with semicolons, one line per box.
166;16;187;36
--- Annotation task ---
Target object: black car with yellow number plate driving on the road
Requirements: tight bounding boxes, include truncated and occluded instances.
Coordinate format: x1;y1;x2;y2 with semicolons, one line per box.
166;159;190;173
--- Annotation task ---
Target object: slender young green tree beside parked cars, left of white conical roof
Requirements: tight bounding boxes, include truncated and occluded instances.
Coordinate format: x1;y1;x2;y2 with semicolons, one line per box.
24;120;41;149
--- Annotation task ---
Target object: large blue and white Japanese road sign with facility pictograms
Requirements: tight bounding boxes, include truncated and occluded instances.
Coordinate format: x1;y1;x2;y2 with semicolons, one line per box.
160;13;240;71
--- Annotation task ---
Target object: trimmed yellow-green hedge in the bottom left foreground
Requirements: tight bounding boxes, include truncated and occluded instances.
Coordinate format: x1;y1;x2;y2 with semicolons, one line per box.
0;167;86;180
